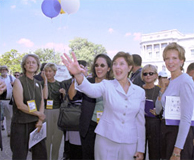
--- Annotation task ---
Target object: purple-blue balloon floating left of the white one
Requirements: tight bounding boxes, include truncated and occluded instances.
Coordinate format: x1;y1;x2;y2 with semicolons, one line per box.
41;0;61;18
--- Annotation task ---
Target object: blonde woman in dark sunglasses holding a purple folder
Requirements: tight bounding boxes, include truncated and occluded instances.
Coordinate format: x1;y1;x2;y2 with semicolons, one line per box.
141;64;160;160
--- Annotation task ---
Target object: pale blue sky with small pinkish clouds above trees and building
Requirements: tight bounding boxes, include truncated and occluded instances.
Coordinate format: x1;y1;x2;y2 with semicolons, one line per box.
0;0;194;57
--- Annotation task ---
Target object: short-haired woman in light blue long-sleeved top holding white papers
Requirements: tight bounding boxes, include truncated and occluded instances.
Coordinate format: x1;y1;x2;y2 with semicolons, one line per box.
156;43;194;160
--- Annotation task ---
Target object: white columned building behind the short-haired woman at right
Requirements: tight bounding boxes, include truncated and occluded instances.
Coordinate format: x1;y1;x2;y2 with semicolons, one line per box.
140;29;194;74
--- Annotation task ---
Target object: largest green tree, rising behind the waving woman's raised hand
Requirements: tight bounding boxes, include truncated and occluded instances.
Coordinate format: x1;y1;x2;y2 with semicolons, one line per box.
69;38;107;65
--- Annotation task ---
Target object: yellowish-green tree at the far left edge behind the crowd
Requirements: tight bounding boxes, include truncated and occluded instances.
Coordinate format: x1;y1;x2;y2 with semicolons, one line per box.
0;49;25;73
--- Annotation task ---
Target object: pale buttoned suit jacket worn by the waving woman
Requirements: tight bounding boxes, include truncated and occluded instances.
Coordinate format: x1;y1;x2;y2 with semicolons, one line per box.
75;77;145;152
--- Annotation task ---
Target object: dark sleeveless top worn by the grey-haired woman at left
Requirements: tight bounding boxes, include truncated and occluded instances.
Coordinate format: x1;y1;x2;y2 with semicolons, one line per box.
12;75;42;123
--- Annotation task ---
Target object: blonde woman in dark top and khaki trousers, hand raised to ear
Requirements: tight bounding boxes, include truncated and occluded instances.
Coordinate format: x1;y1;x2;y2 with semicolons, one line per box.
43;63;65;160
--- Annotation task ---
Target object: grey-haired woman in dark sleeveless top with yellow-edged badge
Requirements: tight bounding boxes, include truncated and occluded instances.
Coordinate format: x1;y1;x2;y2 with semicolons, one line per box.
10;54;47;160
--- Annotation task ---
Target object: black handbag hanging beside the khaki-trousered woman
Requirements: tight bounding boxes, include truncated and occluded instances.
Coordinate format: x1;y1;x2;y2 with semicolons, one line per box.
57;94;81;131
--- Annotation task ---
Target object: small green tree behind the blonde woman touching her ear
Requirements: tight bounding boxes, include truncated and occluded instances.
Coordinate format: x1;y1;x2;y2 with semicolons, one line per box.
34;48;61;65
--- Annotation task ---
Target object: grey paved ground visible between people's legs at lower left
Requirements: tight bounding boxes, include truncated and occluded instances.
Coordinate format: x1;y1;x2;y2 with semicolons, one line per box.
0;121;64;160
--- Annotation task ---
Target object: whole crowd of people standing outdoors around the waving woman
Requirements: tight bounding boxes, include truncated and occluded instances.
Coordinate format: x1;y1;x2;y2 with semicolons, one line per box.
0;43;194;160
